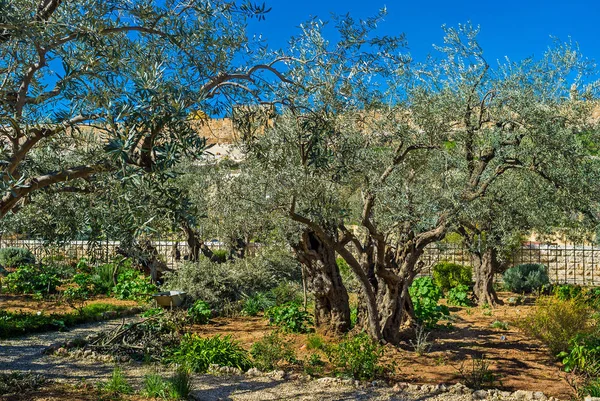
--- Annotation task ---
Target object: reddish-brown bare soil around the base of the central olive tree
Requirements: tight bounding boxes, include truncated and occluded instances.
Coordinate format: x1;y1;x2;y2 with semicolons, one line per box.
194;294;573;399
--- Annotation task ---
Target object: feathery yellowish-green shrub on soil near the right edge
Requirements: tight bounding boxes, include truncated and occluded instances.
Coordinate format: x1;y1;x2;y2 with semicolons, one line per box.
520;296;592;355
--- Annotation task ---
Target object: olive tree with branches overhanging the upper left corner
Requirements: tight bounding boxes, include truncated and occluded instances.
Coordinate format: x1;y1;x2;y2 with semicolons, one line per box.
0;0;287;217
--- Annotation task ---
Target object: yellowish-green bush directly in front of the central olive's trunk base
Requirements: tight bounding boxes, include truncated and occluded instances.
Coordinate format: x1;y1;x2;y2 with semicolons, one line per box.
326;333;383;380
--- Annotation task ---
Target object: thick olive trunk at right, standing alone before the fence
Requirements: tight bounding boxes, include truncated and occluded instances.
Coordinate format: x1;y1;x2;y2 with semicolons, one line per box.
473;247;501;306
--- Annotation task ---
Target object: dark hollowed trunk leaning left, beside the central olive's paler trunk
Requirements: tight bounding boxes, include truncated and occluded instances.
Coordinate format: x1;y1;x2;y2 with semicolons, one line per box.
294;231;350;335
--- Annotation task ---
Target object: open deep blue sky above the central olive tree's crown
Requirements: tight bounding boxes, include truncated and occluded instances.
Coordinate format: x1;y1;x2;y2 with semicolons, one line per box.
249;0;600;63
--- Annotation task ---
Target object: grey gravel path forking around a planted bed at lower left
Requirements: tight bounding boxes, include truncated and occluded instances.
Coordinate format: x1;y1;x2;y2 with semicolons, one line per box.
0;318;143;381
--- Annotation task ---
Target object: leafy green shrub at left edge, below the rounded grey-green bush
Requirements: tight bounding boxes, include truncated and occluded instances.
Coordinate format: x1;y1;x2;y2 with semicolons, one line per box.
2;265;61;295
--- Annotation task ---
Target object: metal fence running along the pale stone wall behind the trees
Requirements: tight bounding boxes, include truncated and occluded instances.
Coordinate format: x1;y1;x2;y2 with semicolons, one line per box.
0;238;600;286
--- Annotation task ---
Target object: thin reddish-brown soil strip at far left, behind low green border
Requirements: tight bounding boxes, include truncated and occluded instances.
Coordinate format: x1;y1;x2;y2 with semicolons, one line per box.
0;294;137;314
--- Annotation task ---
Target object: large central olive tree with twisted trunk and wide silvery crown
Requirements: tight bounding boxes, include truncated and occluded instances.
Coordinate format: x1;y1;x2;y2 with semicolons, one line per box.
237;19;596;342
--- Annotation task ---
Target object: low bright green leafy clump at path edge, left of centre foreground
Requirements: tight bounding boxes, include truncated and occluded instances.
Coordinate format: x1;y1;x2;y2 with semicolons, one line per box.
170;334;252;373
